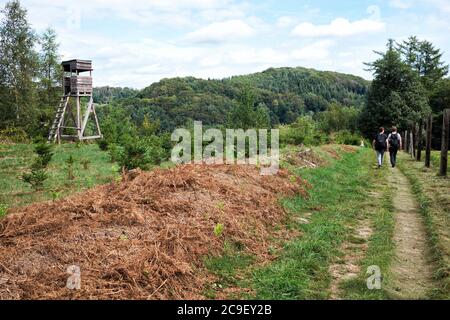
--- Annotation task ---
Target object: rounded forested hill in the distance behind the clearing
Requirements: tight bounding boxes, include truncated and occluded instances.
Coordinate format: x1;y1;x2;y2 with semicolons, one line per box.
95;68;369;130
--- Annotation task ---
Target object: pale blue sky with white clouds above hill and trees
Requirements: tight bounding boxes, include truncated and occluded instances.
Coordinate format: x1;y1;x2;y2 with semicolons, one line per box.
0;0;450;88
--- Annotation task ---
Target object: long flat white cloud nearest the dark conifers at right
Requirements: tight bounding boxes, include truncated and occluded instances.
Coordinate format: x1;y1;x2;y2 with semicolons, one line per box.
292;18;385;37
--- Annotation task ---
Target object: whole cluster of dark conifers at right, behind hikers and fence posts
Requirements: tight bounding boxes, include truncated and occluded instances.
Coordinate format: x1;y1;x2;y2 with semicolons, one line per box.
360;36;450;149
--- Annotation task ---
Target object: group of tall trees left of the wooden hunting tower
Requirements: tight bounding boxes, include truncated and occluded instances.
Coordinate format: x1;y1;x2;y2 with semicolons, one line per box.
0;0;62;136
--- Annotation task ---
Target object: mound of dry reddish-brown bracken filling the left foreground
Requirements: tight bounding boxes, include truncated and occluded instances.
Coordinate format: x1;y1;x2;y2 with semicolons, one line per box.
0;165;308;299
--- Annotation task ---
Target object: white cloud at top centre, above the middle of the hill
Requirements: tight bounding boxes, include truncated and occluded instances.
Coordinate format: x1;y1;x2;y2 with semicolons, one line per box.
186;19;255;43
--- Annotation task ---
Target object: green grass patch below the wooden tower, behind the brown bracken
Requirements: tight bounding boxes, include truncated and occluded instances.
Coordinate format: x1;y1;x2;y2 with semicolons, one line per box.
0;143;119;207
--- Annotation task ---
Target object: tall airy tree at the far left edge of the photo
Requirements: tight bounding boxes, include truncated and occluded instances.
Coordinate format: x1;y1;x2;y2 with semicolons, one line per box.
0;0;38;132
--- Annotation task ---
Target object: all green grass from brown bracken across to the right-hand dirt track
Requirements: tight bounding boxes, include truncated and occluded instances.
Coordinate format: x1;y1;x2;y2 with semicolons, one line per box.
200;146;394;299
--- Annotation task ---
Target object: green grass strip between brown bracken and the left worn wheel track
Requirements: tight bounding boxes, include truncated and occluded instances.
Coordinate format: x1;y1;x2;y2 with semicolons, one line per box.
252;149;373;299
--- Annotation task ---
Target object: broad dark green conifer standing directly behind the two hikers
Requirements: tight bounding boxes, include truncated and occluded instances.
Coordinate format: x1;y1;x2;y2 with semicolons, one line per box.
360;40;430;136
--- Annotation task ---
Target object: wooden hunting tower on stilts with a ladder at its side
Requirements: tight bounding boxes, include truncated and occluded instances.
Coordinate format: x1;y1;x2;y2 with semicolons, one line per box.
48;59;102;143
